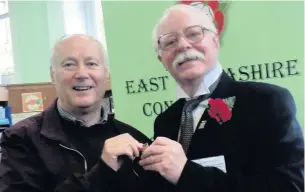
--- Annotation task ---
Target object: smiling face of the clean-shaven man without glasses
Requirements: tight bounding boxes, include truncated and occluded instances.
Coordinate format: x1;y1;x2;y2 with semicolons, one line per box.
51;36;107;111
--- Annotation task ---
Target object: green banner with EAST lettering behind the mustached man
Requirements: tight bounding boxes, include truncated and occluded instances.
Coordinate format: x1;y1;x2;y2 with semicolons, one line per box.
102;1;304;136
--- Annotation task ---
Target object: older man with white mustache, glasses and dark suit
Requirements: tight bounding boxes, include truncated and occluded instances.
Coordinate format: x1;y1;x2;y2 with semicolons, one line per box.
140;5;304;192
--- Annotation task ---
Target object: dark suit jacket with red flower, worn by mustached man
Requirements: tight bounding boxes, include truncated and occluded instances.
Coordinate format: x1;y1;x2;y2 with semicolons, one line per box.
154;73;304;192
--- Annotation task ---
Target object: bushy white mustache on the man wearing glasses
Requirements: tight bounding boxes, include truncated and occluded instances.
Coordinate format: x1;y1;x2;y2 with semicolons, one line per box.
172;50;204;69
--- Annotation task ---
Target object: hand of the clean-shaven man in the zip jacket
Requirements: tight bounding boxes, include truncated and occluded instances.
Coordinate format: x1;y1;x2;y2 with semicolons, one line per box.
101;133;142;171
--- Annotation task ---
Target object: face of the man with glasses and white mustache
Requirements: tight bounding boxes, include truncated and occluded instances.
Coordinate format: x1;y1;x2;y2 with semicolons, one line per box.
157;8;219;83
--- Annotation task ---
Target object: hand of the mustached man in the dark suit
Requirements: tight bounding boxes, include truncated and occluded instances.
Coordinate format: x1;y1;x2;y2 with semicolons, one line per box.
139;137;187;184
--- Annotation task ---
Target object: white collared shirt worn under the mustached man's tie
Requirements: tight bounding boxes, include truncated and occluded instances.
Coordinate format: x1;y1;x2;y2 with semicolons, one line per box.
177;63;223;135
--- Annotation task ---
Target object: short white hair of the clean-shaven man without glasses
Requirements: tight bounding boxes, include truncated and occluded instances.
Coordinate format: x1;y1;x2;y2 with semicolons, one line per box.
51;34;109;71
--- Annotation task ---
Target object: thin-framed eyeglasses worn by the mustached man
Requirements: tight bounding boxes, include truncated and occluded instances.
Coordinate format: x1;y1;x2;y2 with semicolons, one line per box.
158;25;214;51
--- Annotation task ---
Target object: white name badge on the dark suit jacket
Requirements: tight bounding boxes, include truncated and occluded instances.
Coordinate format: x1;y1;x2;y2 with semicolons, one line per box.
192;155;227;173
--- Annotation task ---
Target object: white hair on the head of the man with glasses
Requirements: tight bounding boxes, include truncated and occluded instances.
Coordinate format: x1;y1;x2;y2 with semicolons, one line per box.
152;4;217;55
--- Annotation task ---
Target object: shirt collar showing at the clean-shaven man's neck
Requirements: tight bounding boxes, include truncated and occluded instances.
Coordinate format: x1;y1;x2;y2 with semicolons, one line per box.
57;102;108;127
